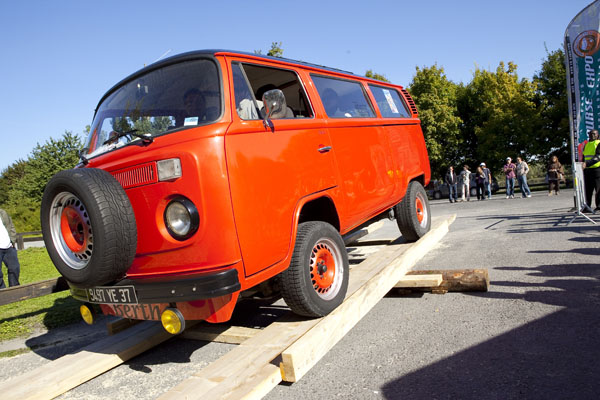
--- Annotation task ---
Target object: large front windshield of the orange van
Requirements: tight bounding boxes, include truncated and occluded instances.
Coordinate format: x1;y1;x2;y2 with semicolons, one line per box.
83;59;221;158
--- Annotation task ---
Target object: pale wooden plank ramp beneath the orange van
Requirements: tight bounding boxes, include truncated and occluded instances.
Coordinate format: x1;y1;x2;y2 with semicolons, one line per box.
0;216;455;400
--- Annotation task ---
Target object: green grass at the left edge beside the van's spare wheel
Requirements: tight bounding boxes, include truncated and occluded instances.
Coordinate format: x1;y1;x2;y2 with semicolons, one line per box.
0;247;81;341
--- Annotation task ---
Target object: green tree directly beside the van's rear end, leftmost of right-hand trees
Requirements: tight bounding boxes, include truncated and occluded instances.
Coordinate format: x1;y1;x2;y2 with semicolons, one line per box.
409;64;463;177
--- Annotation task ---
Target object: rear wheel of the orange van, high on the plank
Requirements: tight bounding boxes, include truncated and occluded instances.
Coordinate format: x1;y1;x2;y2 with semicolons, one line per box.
395;181;431;242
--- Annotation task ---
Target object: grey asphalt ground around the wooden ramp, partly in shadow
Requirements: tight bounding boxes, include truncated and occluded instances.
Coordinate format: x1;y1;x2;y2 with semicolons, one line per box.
0;190;600;400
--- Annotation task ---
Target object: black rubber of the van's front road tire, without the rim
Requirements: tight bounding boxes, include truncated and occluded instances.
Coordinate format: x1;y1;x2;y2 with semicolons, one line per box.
279;221;350;317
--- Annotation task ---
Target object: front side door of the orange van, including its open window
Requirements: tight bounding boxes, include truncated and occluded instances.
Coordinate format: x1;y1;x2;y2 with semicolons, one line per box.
225;60;336;276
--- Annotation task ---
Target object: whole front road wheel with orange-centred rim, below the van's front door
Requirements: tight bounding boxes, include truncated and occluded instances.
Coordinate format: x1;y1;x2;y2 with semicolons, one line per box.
279;221;350;317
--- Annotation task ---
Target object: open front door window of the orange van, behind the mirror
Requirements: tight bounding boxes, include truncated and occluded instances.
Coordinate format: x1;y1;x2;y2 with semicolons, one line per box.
232;63;313;119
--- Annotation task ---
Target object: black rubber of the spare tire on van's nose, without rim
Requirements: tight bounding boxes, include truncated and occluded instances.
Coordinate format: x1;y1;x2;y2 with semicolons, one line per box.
41;168;137;287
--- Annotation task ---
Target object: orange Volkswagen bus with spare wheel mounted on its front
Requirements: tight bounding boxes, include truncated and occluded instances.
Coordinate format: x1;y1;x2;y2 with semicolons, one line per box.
41;51;431;333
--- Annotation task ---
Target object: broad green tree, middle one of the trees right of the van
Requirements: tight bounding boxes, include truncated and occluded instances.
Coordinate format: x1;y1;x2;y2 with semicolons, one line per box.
458;62;540;170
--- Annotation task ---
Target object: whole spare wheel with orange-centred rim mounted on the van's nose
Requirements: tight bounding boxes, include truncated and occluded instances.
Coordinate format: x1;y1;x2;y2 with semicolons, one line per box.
41;168;137;287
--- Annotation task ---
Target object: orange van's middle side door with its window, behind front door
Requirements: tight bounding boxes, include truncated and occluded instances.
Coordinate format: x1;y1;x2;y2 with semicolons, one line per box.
311;75;396;232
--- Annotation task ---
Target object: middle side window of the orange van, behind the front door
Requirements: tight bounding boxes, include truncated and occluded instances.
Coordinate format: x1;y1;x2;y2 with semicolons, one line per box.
311;75;375;118
